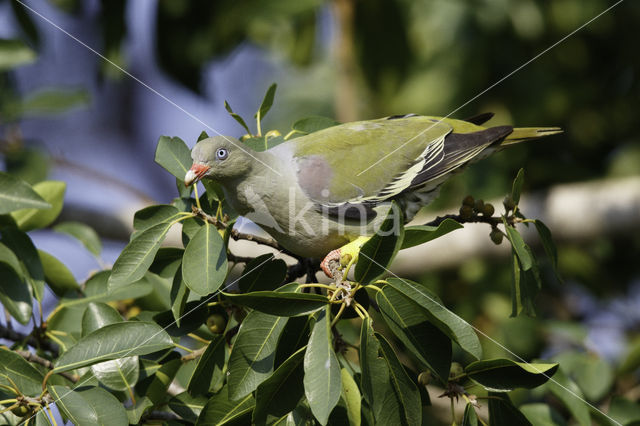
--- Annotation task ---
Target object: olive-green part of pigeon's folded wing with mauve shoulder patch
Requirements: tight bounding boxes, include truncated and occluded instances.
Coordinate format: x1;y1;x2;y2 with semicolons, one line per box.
291;116;452;207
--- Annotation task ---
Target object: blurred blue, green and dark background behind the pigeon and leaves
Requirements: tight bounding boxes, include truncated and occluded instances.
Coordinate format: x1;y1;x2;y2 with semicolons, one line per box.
0;0;640;420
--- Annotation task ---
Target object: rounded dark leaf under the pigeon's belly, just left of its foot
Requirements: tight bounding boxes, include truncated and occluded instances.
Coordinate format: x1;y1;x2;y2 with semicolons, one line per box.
238;253;287;293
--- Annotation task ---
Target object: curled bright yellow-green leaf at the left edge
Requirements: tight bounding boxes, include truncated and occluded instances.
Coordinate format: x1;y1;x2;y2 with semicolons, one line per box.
11;180;67;231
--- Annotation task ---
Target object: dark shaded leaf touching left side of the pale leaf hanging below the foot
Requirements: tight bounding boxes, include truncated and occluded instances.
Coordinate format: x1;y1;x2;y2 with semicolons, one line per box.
252;348;305;424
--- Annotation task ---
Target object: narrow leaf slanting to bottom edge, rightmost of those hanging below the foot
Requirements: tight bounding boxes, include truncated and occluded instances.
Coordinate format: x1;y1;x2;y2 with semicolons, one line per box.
374;333;422;425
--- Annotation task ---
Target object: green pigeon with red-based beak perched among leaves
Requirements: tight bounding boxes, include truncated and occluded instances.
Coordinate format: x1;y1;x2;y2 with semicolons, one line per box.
185;114;561;277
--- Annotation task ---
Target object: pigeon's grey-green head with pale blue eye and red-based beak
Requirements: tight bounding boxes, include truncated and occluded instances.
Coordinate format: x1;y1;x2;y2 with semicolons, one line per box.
184;136;253;186
